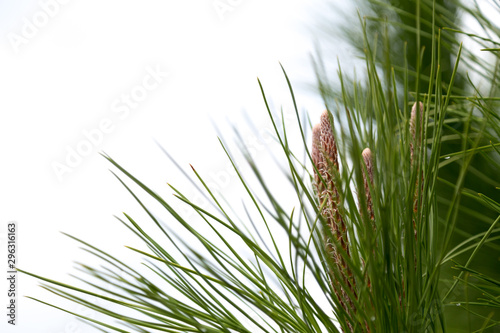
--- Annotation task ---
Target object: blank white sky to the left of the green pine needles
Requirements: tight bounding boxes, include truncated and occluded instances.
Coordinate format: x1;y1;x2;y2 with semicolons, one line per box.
0;0;360;333
